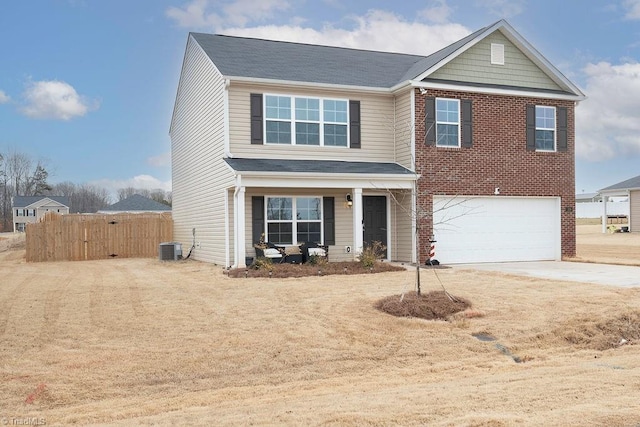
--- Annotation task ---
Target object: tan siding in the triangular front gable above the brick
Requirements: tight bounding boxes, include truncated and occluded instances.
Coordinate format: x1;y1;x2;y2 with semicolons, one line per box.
429;31;561;90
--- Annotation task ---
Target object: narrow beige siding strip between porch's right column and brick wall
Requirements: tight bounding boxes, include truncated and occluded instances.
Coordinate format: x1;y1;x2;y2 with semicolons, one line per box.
391;191;413;262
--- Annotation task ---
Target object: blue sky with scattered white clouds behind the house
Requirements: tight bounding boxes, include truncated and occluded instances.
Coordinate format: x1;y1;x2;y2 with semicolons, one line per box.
0;0;640;197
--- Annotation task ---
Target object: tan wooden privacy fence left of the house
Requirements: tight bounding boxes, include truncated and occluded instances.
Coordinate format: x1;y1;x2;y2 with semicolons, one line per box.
26;213;173;262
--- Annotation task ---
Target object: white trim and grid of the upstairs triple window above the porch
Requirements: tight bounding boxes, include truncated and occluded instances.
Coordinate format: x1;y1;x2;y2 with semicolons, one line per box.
262;93;351;149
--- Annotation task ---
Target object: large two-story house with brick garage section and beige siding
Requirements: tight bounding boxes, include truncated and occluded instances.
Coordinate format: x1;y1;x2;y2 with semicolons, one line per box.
169;21;584;267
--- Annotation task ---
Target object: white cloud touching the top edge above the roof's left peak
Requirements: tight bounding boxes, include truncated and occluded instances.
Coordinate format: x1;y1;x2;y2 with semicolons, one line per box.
166;0;289;31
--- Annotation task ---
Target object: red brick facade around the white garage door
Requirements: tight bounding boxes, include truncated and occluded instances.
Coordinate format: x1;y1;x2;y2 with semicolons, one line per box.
416;89;576;263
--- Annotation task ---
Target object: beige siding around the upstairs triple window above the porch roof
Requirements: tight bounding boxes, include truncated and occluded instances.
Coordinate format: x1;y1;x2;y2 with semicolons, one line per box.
229;82;394;162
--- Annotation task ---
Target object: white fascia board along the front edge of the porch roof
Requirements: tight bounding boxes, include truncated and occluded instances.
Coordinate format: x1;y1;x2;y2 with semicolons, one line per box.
236;172;419;190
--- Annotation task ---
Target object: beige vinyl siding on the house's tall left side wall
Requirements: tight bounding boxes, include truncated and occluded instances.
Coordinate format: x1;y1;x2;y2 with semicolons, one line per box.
170;37;233;265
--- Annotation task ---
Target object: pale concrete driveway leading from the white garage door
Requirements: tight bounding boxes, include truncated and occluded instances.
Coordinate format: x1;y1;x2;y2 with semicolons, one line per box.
453;261;640;288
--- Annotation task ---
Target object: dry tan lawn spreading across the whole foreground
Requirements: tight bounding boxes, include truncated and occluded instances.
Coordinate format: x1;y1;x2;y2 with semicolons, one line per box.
0;234;640;426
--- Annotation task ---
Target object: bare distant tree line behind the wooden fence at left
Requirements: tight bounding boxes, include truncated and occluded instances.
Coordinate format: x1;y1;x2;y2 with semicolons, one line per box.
0;151;171;231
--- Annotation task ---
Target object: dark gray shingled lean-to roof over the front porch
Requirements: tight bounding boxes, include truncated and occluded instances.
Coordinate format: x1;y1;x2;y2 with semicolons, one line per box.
224;158;414;175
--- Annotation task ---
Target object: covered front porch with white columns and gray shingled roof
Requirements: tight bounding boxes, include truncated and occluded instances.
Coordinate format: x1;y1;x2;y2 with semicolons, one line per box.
225;159;416;268
